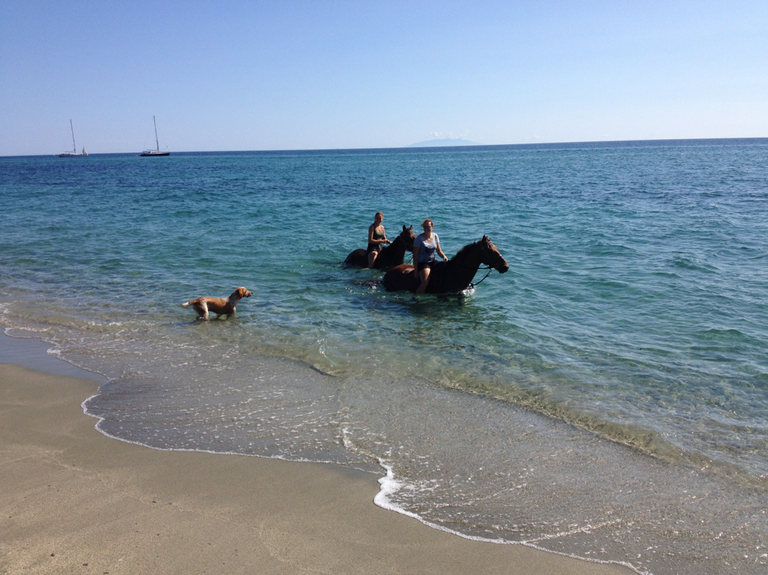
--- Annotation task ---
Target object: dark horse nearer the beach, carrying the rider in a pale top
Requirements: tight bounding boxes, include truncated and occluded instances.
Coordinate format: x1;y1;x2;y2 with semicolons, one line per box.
382;236;509;294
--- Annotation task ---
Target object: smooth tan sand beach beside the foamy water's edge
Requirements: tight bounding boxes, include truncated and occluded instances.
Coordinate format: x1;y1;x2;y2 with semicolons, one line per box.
0;335;633;575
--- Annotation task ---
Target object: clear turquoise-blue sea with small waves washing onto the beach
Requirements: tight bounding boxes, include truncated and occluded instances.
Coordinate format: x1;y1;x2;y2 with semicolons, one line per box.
0;139;768;575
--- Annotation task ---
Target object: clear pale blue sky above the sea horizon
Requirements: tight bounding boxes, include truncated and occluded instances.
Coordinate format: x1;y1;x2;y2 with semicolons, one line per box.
0;0;768;156
